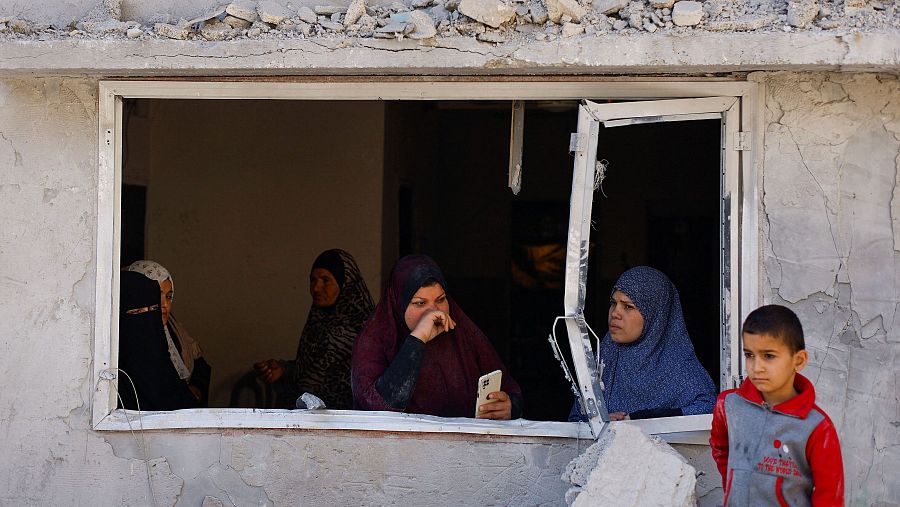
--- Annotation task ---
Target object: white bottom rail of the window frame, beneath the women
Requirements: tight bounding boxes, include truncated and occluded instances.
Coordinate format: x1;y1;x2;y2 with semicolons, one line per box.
94;408;712;444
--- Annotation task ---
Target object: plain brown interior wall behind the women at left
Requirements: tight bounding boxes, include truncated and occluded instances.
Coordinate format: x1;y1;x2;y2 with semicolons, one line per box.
134;100;384;407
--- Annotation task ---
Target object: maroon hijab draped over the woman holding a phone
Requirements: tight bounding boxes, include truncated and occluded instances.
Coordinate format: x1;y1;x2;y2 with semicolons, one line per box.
353;255;522;417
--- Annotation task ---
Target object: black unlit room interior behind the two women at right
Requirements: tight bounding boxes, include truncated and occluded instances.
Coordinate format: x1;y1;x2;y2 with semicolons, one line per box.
385;101;721;420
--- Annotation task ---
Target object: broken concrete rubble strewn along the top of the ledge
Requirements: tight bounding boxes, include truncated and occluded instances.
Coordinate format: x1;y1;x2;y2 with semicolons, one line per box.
0;0;900;44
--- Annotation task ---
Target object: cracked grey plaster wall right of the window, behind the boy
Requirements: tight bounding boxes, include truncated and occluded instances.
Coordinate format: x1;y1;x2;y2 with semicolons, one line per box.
762;73;900;505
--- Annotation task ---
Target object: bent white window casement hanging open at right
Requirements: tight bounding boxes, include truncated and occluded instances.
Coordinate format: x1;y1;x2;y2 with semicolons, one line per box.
564;97;740;437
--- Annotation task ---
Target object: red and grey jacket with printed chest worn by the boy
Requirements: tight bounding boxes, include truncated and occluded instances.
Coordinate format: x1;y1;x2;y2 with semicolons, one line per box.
709;374;844;506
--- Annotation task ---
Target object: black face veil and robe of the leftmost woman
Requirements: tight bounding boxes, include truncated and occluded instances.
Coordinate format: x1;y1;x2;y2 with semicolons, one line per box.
118;271;197;410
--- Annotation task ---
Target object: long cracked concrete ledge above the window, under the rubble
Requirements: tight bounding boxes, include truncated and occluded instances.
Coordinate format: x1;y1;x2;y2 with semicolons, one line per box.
0;30;900;77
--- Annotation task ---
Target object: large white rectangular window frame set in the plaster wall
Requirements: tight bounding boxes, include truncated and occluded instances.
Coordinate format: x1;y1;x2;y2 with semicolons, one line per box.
92;77;763;443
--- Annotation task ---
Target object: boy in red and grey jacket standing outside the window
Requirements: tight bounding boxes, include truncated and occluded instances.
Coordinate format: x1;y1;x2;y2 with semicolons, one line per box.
709;305;844;506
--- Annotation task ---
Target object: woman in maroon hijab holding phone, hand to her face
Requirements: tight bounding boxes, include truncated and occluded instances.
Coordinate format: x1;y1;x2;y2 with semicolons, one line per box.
351;255;522;419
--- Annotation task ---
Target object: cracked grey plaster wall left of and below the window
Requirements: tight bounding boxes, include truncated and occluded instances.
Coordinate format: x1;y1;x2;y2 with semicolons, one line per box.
0;74;586;506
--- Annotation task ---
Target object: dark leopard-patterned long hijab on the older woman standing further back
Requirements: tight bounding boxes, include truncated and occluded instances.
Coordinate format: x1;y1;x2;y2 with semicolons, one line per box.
285;249;374;409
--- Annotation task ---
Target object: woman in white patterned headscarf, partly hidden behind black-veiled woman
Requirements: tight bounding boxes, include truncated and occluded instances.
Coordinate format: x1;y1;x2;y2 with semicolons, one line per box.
126;260;212;407
